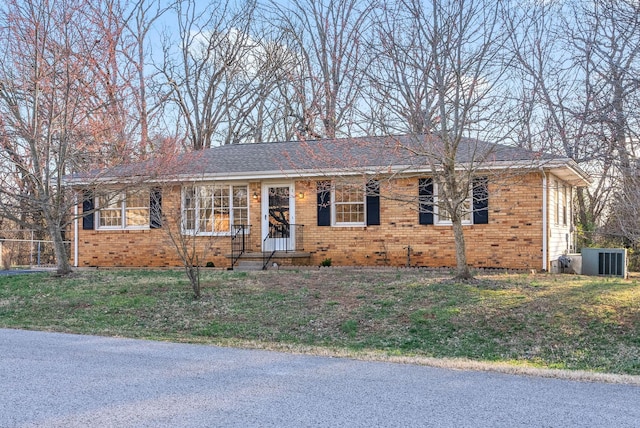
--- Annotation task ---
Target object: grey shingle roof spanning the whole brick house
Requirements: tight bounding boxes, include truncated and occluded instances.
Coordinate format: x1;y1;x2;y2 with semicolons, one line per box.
68;135;592;182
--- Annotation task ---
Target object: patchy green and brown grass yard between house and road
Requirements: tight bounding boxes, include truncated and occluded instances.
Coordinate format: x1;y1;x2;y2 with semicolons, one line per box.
0;268;640;375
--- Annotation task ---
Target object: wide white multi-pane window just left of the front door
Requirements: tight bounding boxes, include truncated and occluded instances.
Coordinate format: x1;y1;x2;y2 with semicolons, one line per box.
182;184;249;235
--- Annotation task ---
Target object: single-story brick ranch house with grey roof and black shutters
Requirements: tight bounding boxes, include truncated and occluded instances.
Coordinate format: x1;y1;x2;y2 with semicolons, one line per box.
66;136;589;270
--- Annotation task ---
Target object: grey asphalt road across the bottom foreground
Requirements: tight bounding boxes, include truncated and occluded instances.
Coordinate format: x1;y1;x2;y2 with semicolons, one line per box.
0;329;640;427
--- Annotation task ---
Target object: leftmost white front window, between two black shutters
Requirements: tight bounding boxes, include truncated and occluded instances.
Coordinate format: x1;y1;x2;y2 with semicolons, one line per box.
97;189;149;229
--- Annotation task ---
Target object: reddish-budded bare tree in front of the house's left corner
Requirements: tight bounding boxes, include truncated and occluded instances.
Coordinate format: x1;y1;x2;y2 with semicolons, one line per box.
0;0;139;274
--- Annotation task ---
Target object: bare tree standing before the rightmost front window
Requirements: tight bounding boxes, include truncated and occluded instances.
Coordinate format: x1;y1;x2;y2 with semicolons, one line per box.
369;0;504;279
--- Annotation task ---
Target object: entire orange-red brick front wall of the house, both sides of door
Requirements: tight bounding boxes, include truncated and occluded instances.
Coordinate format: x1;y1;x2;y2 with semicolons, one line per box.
71;173;542;269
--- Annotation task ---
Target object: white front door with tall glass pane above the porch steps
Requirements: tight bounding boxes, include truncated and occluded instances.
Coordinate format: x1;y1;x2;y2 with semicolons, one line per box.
262;184;295;251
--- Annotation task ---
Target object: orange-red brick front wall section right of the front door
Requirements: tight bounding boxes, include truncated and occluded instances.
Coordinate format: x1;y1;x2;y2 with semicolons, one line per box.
296;174;542;269
